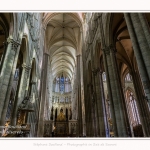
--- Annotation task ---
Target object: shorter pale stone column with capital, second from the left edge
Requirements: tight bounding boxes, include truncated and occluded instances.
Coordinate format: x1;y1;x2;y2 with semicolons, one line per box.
11;64;31;126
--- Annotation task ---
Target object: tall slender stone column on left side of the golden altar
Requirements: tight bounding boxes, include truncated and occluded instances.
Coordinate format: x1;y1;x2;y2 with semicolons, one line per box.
37;53;49;137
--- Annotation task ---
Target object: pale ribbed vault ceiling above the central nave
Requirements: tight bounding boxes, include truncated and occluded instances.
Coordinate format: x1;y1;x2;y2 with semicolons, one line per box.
46;13;80;79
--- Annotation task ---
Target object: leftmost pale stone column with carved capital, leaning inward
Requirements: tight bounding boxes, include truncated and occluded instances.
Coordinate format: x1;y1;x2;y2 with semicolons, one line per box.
0;38;20;134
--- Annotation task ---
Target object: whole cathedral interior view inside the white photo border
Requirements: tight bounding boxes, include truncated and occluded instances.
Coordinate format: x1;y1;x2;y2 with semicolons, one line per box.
0;12;150;138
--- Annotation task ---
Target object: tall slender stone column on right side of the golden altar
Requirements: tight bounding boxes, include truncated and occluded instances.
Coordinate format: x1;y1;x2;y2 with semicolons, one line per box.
77;55;83;137
